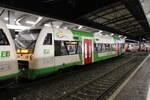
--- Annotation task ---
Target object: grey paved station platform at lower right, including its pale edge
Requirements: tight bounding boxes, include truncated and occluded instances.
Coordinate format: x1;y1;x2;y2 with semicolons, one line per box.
108;55;150;100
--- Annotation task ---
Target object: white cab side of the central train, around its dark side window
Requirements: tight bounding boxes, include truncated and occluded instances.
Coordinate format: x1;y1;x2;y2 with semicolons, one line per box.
29;27;54;69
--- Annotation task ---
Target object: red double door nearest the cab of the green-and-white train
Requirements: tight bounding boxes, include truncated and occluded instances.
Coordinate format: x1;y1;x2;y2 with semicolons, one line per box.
84;39;92;64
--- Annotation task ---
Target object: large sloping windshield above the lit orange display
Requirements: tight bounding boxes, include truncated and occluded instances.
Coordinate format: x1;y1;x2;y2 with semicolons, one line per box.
15;29;41;49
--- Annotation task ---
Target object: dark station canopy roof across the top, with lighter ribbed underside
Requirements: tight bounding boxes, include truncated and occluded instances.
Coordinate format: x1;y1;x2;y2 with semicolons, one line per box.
0;0;150;40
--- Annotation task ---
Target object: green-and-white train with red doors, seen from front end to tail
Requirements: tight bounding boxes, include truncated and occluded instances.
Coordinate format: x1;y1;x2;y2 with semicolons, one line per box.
14;24;125;79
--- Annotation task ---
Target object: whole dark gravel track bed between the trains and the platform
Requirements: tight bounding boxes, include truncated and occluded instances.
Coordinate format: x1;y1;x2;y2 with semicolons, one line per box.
0;53;147;100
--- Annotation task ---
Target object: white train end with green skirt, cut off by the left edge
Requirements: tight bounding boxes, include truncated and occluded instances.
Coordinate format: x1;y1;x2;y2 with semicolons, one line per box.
0;24;18;80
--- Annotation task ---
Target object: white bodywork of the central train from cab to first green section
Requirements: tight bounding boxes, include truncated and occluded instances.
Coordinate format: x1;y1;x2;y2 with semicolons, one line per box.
30;27;80;69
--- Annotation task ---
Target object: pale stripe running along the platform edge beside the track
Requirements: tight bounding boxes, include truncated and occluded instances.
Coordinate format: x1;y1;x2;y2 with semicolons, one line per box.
108;55;150;100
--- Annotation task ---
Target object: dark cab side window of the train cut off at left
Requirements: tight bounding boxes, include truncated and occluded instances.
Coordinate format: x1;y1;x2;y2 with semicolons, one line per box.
0;29;9;45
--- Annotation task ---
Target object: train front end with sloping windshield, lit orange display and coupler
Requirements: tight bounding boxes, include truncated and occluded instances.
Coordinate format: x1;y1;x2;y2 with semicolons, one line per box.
15;29;40;78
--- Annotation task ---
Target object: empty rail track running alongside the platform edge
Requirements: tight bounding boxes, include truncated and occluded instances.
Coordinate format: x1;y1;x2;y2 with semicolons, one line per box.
56;56;145;100
